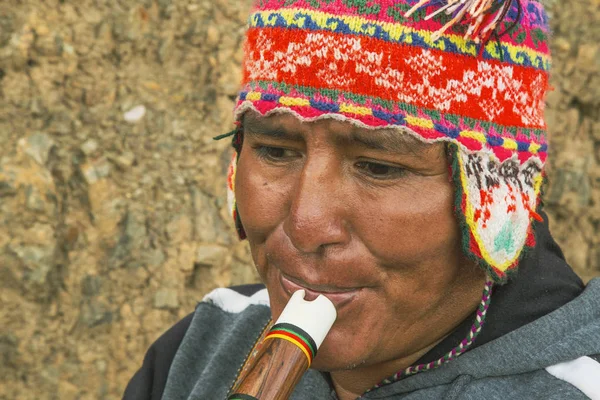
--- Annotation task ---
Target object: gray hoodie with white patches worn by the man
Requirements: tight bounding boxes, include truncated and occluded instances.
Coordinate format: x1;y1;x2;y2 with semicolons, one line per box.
163;279;600;400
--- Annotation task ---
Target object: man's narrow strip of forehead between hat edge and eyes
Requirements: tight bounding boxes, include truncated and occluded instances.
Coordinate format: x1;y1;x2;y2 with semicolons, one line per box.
242;112;429;152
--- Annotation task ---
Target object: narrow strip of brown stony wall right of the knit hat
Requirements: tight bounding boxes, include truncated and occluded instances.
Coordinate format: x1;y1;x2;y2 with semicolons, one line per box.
545;0;600;280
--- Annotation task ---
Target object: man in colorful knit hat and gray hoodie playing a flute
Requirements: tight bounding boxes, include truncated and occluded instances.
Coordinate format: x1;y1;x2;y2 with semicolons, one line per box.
125;0;600;400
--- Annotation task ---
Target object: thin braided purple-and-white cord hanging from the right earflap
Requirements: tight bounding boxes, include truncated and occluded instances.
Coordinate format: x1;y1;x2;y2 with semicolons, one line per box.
367;277;494;392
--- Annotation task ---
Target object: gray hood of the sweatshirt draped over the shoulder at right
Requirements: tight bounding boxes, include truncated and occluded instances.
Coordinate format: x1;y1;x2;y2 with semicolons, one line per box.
363;279;600;399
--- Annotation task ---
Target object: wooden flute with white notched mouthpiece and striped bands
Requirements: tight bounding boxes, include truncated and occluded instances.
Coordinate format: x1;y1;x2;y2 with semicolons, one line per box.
228;290;337;400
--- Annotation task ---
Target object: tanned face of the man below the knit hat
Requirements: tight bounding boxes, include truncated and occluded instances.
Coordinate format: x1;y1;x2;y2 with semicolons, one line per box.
235;112;484;373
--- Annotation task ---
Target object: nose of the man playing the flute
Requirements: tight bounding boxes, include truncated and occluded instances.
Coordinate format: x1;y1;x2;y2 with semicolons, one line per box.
283;160;350;253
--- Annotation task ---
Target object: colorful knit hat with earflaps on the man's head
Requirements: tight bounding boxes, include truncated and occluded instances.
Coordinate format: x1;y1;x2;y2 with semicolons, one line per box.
229;0;550;283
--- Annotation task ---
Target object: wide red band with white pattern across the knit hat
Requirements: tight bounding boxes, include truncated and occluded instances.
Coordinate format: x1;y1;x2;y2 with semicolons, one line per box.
243;28;548;129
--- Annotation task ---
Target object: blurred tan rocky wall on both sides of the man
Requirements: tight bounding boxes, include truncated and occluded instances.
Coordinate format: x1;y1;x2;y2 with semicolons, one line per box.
0;0;600;400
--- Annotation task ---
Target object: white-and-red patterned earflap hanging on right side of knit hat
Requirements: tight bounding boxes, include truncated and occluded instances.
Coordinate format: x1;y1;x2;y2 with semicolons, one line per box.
448;144;543;284
